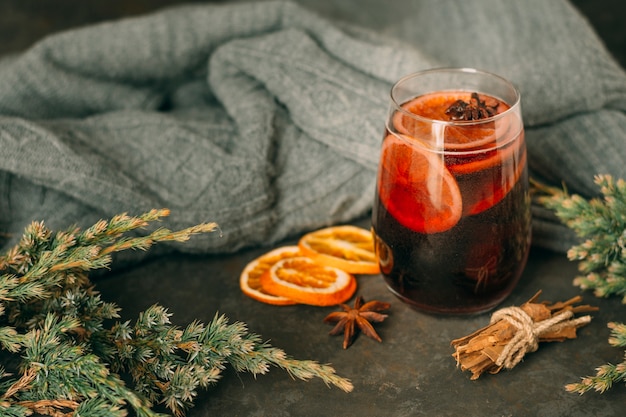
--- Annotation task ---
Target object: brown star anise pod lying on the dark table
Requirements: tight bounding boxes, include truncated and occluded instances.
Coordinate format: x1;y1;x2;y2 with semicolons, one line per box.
324;296;391;349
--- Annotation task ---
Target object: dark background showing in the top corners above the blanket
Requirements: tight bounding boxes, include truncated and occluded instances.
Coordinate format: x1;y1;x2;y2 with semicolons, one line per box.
0;0;626;68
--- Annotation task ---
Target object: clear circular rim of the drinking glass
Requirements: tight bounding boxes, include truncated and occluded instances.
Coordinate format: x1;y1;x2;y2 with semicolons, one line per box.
389;67;521;126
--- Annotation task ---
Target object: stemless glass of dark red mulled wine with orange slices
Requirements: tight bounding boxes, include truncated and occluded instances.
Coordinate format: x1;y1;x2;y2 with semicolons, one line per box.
372;69;531;314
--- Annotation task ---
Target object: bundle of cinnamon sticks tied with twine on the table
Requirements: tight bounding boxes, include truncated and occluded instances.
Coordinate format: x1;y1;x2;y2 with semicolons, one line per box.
451;291;598;380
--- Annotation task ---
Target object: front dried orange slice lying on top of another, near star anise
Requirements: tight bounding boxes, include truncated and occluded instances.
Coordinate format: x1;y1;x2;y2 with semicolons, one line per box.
261;256;357;306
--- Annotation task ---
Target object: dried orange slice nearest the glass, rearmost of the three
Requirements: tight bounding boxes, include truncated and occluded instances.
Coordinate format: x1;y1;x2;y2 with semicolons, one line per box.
298;225;380;274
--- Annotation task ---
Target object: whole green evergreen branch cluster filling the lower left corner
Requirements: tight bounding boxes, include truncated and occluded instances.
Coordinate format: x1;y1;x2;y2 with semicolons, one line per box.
0;210;352;417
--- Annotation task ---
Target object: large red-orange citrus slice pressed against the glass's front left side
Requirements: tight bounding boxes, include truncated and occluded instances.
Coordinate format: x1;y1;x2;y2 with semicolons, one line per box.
378;135;463;233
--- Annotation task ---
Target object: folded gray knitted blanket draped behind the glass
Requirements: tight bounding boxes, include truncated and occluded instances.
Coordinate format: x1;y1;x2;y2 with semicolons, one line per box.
0;0;626;256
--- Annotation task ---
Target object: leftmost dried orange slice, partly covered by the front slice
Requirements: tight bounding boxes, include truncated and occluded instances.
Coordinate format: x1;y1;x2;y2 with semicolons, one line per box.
239;246;300;305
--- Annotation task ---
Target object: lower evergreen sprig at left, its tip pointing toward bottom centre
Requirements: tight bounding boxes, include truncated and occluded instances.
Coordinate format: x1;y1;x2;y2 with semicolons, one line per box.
98;305;352;415
